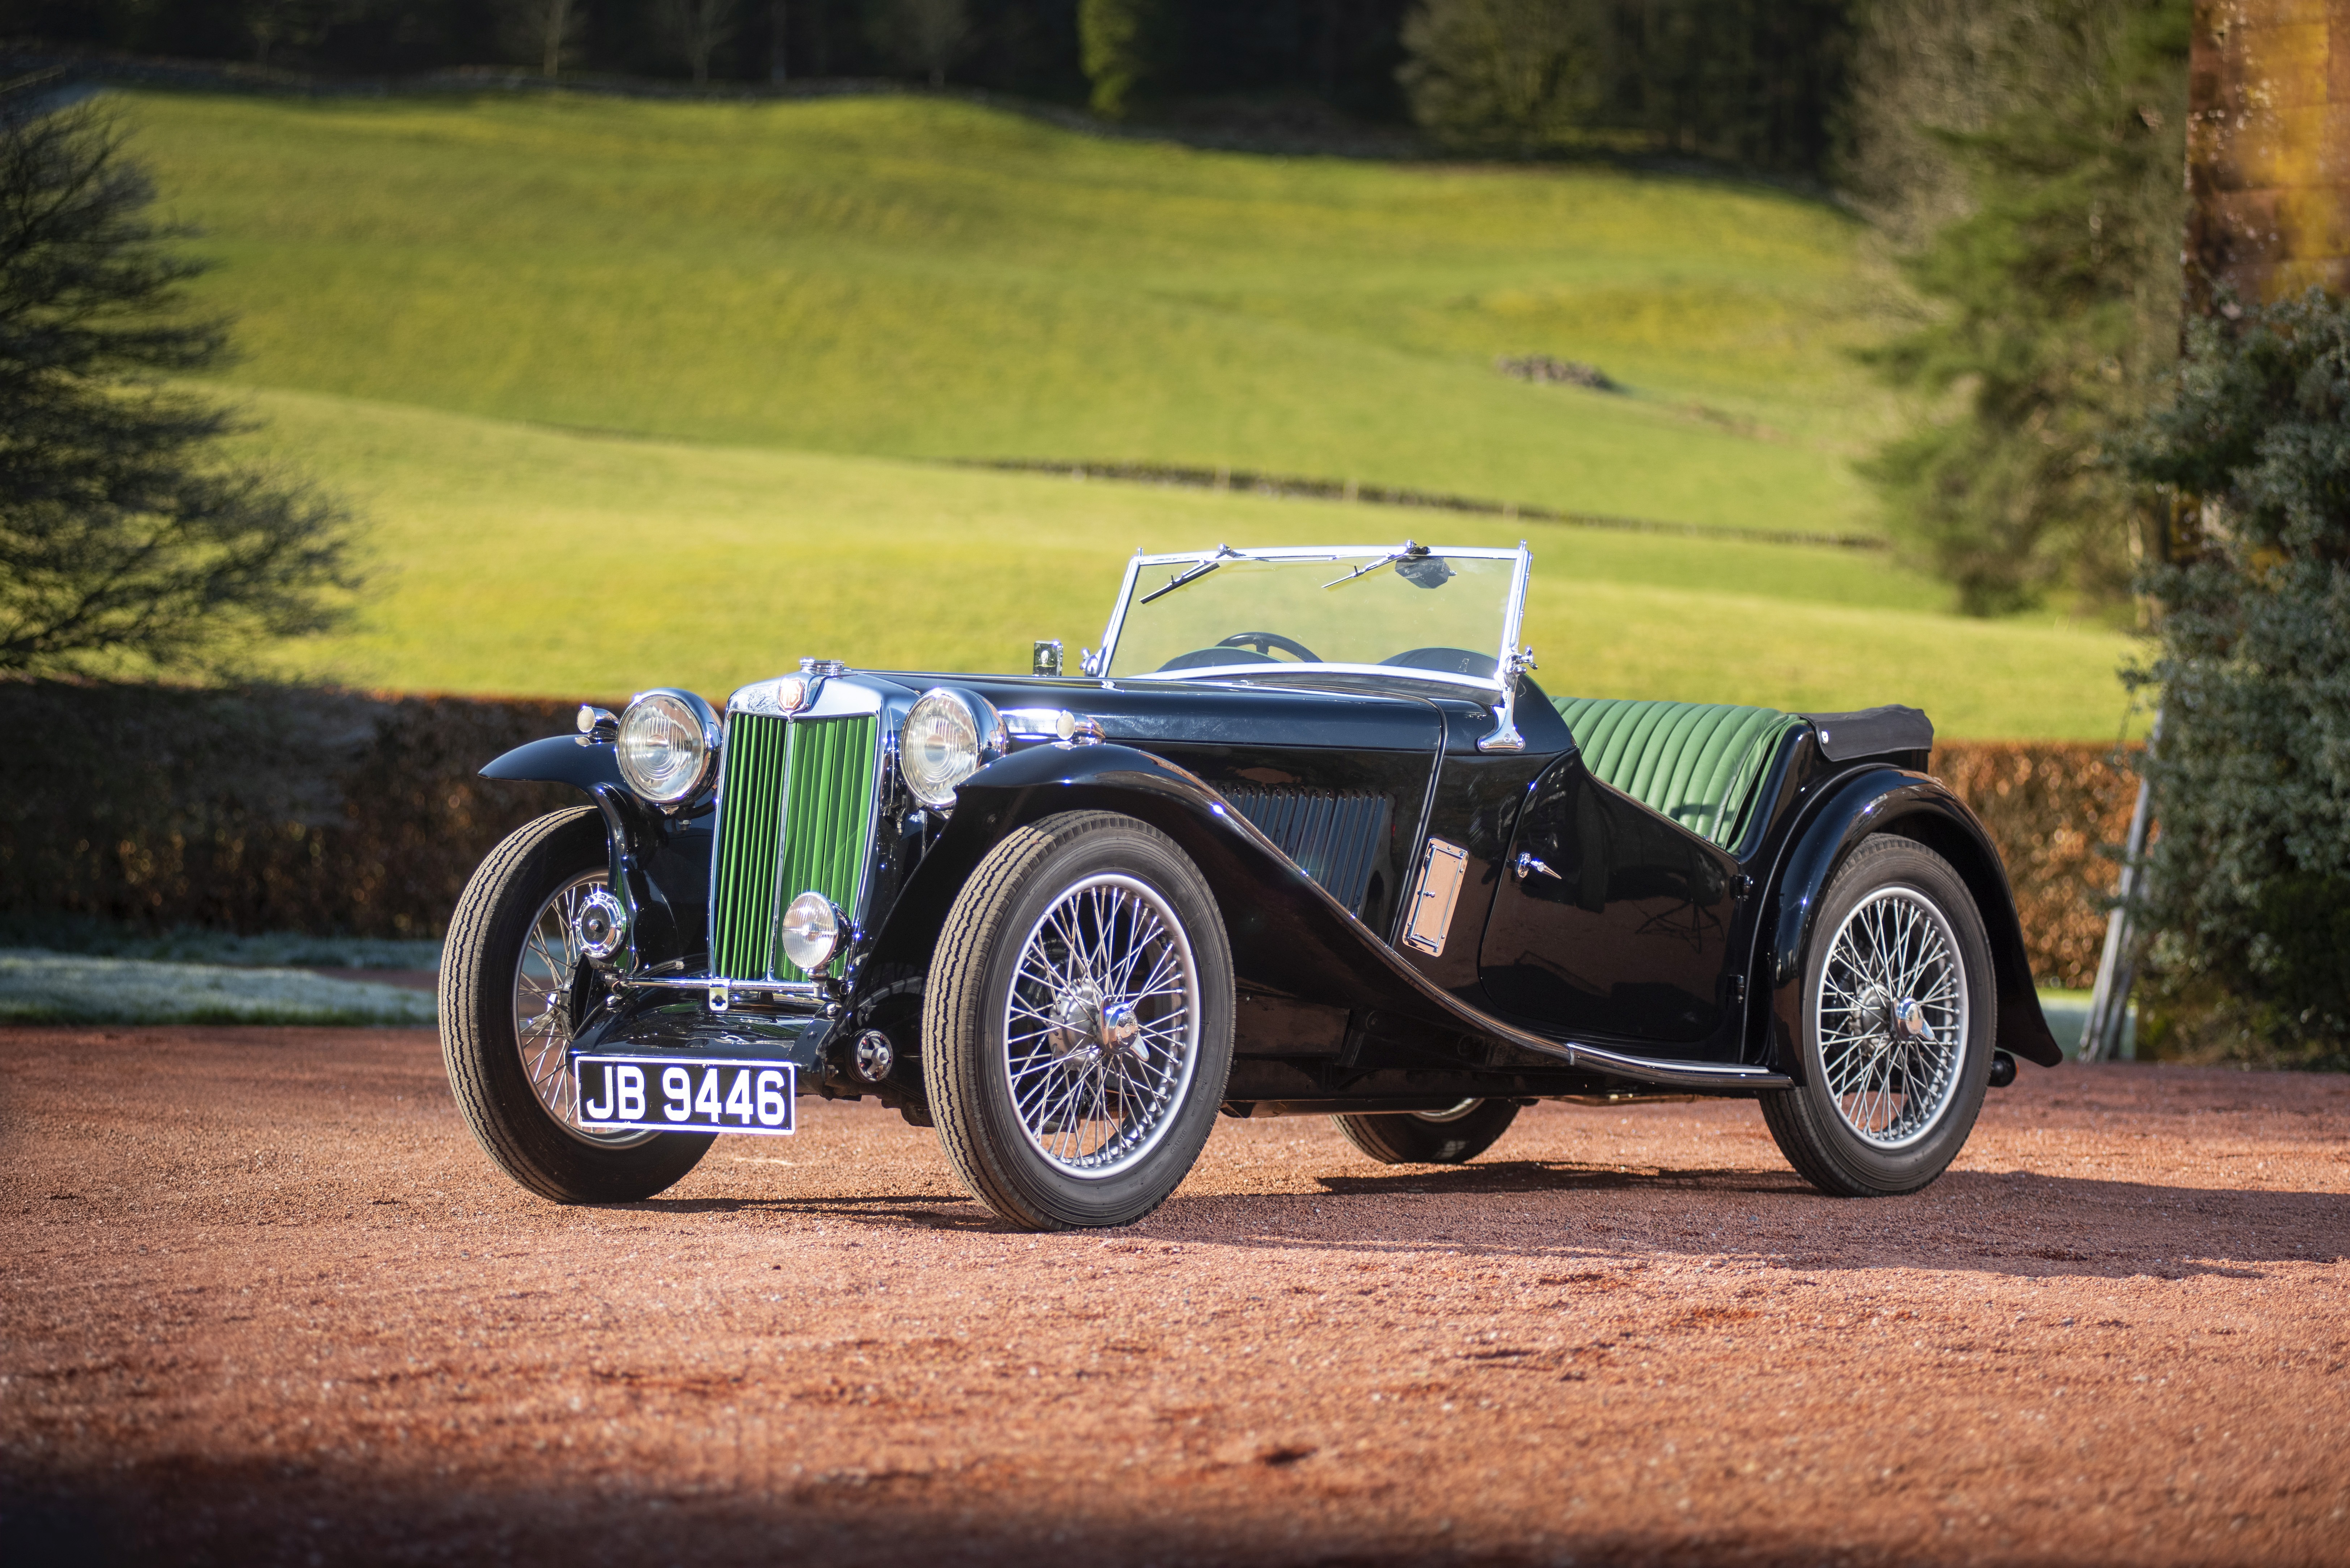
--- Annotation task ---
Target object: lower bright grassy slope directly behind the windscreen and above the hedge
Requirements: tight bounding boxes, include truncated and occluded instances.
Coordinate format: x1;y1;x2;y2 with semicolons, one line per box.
252;393;2127;738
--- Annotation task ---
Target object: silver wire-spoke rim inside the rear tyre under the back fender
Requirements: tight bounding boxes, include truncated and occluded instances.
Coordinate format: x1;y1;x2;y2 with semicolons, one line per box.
1817;886;1969;1149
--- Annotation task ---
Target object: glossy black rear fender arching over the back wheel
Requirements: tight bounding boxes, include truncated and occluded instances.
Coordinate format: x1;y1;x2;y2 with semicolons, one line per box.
1758;766;2063;1072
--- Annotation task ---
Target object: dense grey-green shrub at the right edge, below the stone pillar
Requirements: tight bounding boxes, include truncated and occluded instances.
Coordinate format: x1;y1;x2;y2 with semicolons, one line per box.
2129;291;2350;1067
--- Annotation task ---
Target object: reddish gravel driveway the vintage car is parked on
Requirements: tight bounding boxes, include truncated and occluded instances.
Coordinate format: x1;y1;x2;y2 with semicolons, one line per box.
0;1030;2350;1568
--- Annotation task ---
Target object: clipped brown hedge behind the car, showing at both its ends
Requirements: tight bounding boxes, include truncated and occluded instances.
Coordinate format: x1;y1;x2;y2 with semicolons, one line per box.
0;682;2136;988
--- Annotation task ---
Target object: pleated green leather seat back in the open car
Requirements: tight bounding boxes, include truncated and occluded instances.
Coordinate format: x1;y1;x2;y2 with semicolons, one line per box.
1551;696;1803;846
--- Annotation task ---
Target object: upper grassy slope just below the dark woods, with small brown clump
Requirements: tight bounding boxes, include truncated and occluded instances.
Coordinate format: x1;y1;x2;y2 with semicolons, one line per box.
127;94;1885;545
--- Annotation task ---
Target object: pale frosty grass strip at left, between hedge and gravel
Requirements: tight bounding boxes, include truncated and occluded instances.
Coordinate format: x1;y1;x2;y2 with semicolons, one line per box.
0;947;435;1025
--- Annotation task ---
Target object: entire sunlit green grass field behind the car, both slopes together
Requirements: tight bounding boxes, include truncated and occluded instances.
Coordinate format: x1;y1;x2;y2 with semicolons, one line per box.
125;94;2129;738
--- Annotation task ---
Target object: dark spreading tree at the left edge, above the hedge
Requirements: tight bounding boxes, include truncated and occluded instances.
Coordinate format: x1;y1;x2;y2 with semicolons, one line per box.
0;99;357;672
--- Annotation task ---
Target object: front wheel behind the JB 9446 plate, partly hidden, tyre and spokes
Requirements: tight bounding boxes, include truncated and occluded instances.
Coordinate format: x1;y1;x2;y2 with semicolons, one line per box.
440;806;710;1204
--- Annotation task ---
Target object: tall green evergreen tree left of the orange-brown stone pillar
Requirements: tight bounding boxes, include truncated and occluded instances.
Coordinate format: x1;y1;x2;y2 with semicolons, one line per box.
1864;0;2188;613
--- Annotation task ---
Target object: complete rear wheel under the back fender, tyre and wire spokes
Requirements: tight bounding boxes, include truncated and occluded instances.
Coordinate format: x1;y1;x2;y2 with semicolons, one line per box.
1762;835;1998;1196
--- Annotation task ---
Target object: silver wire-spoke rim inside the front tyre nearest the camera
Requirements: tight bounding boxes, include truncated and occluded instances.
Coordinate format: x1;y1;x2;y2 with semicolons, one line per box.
1001;872;1201;1178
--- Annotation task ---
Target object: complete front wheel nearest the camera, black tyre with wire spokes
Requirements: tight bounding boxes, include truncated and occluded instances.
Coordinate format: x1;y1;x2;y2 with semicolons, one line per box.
921;811;1234;1229
